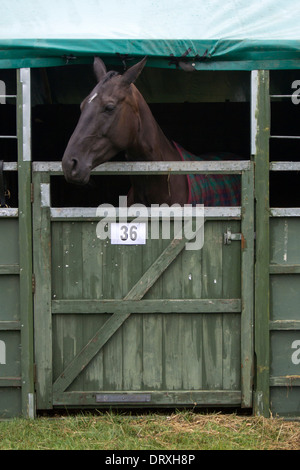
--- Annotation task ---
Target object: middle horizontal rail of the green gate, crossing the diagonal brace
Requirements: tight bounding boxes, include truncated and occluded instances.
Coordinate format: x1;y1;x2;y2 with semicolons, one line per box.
52;299;241;315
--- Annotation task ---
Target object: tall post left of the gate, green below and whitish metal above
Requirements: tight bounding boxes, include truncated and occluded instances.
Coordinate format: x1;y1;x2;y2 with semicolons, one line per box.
17;69;35;418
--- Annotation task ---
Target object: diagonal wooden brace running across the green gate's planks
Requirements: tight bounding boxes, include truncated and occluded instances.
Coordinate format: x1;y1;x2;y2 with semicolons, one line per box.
53;234;186;393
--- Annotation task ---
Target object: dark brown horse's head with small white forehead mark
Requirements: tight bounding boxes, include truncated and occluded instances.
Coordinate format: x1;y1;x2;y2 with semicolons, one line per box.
62;57;147;184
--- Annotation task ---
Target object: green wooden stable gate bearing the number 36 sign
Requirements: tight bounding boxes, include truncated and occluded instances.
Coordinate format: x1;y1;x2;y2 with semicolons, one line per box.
33;161;254;409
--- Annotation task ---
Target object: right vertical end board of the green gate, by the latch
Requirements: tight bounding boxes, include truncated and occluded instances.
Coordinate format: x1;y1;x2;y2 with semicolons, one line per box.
241;162;254;408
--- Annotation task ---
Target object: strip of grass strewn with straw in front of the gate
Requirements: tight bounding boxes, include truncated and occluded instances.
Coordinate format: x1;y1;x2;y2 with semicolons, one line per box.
0;411;300;450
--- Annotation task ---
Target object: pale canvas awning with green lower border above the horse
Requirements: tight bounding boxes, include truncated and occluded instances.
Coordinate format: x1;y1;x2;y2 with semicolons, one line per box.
0;0;300;70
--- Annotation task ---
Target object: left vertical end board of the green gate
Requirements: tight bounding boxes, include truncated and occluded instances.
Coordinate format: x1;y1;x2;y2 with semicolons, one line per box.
33;173;52;409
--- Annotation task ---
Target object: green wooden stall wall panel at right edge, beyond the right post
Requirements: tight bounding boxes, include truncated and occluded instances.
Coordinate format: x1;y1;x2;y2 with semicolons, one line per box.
269;218;300;418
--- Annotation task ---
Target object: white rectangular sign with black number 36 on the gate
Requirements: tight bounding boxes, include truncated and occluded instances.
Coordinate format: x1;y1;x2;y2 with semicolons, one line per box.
110;222;146;245
